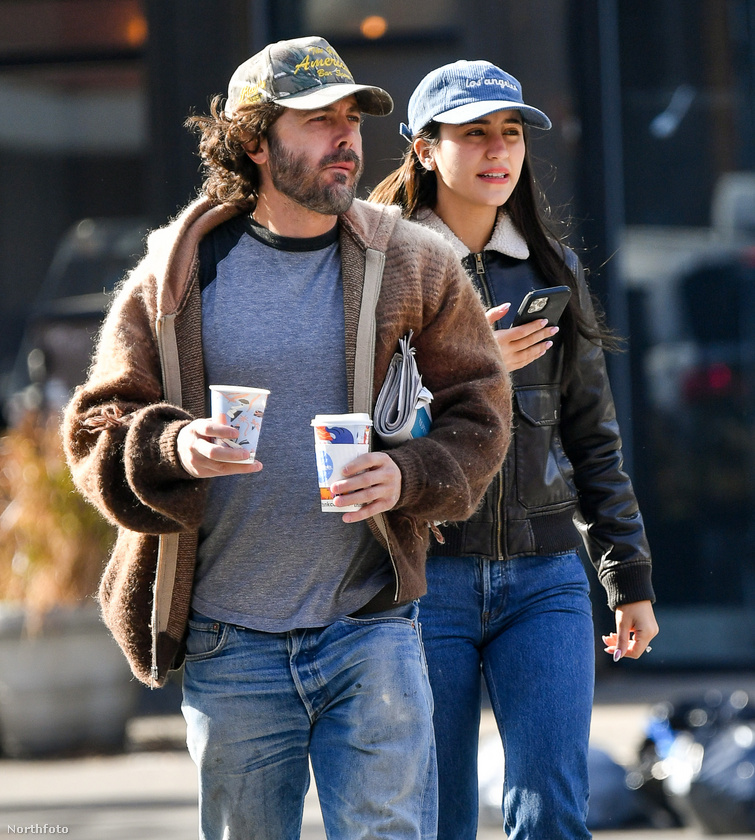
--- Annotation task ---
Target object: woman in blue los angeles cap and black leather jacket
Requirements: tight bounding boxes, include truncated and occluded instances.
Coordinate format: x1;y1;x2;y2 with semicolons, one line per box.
371;61;658;840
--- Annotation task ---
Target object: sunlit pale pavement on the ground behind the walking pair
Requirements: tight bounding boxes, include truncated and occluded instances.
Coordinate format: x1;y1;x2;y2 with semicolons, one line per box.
0;668;746;840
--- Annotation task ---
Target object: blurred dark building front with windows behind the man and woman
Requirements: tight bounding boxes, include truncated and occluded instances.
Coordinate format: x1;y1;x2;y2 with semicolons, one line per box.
0;0;755;672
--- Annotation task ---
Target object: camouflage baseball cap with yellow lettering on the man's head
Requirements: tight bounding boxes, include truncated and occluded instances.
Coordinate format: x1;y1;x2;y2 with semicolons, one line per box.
225;37;393;117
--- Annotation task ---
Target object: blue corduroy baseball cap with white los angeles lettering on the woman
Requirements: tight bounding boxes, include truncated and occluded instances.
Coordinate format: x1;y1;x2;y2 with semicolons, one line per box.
400;61;551;140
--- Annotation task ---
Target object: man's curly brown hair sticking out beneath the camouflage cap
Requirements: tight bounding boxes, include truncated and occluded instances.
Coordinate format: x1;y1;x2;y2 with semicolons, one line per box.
186;95;283;204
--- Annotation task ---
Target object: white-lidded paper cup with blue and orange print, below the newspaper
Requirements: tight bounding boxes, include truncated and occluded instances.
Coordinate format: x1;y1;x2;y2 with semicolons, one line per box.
312;414;372;513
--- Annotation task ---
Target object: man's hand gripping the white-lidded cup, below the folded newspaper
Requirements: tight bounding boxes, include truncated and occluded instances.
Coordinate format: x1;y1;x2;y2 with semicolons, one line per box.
330;452;401;522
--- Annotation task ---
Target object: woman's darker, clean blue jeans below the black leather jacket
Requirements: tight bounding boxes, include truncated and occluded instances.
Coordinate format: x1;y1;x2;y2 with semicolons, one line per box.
420;553;595;840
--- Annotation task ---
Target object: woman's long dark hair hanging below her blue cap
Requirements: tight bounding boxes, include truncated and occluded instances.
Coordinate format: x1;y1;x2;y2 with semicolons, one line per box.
369;121;620;387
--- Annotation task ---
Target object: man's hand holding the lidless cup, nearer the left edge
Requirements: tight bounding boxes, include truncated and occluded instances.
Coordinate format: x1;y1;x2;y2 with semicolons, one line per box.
176;419;262;478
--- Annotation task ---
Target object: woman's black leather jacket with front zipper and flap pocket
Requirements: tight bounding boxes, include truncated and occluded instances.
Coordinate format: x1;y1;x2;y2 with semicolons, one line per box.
430;243;654;609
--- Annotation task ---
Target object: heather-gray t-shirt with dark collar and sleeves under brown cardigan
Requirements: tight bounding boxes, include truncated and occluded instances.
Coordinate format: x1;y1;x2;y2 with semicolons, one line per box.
192;217;392;632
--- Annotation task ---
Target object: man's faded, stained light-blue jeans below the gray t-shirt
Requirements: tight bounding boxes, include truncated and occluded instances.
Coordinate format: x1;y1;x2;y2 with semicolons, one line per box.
182;604;437;840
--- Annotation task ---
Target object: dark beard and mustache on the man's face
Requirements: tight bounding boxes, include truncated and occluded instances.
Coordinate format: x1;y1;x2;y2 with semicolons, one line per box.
267;131;363;216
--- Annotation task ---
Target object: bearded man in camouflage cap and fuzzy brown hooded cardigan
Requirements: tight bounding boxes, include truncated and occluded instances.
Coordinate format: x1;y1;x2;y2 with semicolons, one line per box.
65;38;510;840
